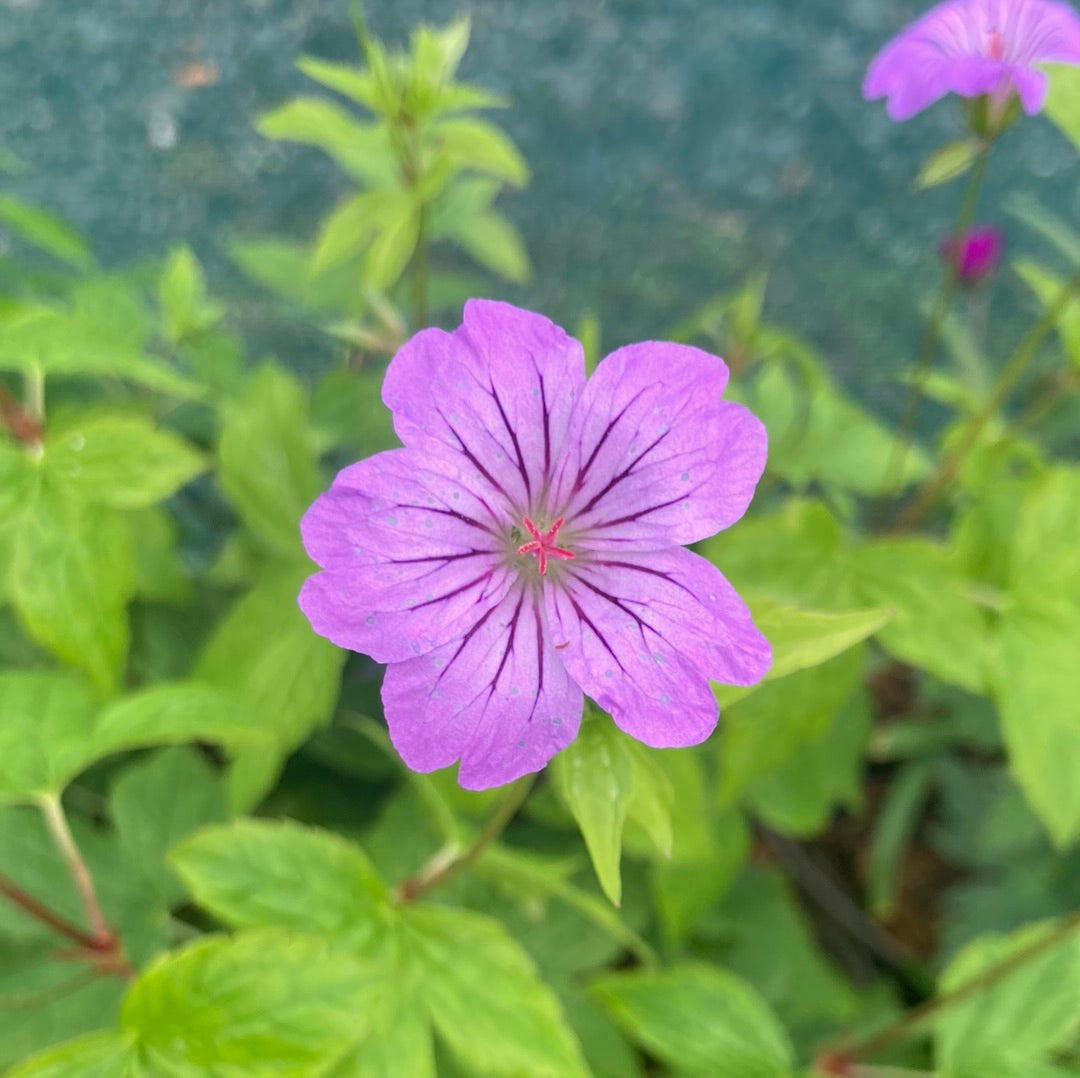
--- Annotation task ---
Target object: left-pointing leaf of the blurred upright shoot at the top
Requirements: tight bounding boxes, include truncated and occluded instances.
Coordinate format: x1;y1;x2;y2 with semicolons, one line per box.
256;97;395;187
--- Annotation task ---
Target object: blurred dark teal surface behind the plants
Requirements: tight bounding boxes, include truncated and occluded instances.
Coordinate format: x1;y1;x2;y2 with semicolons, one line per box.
0;0;1080;412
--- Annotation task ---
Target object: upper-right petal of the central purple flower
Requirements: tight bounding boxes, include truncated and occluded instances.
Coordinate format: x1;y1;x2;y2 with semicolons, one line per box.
552;341;768;550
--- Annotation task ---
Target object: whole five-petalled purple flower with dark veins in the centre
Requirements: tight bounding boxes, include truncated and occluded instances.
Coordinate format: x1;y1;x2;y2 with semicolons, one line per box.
300;300;770;789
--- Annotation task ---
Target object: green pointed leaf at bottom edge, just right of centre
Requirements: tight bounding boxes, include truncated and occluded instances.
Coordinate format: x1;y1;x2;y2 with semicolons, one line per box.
592;964;793;1078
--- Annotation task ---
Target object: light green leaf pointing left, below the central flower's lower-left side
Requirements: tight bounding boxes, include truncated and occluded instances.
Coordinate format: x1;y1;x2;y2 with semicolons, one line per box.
170;820;387;943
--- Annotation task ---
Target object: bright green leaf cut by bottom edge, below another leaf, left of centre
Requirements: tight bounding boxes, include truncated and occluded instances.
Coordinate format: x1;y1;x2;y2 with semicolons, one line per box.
120;931;368;1078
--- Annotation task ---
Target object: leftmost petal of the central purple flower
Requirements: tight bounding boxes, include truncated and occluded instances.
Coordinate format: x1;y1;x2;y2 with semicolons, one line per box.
300;449;514;662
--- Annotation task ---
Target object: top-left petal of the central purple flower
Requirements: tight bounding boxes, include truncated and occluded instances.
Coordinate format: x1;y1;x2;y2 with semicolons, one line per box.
382;299;585;518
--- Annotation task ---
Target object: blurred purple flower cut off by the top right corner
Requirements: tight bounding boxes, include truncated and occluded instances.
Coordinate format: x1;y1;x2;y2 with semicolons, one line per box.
863;0;1080;120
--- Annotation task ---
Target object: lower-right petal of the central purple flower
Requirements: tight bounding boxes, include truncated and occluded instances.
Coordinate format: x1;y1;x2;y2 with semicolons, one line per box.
546;548;771;749
